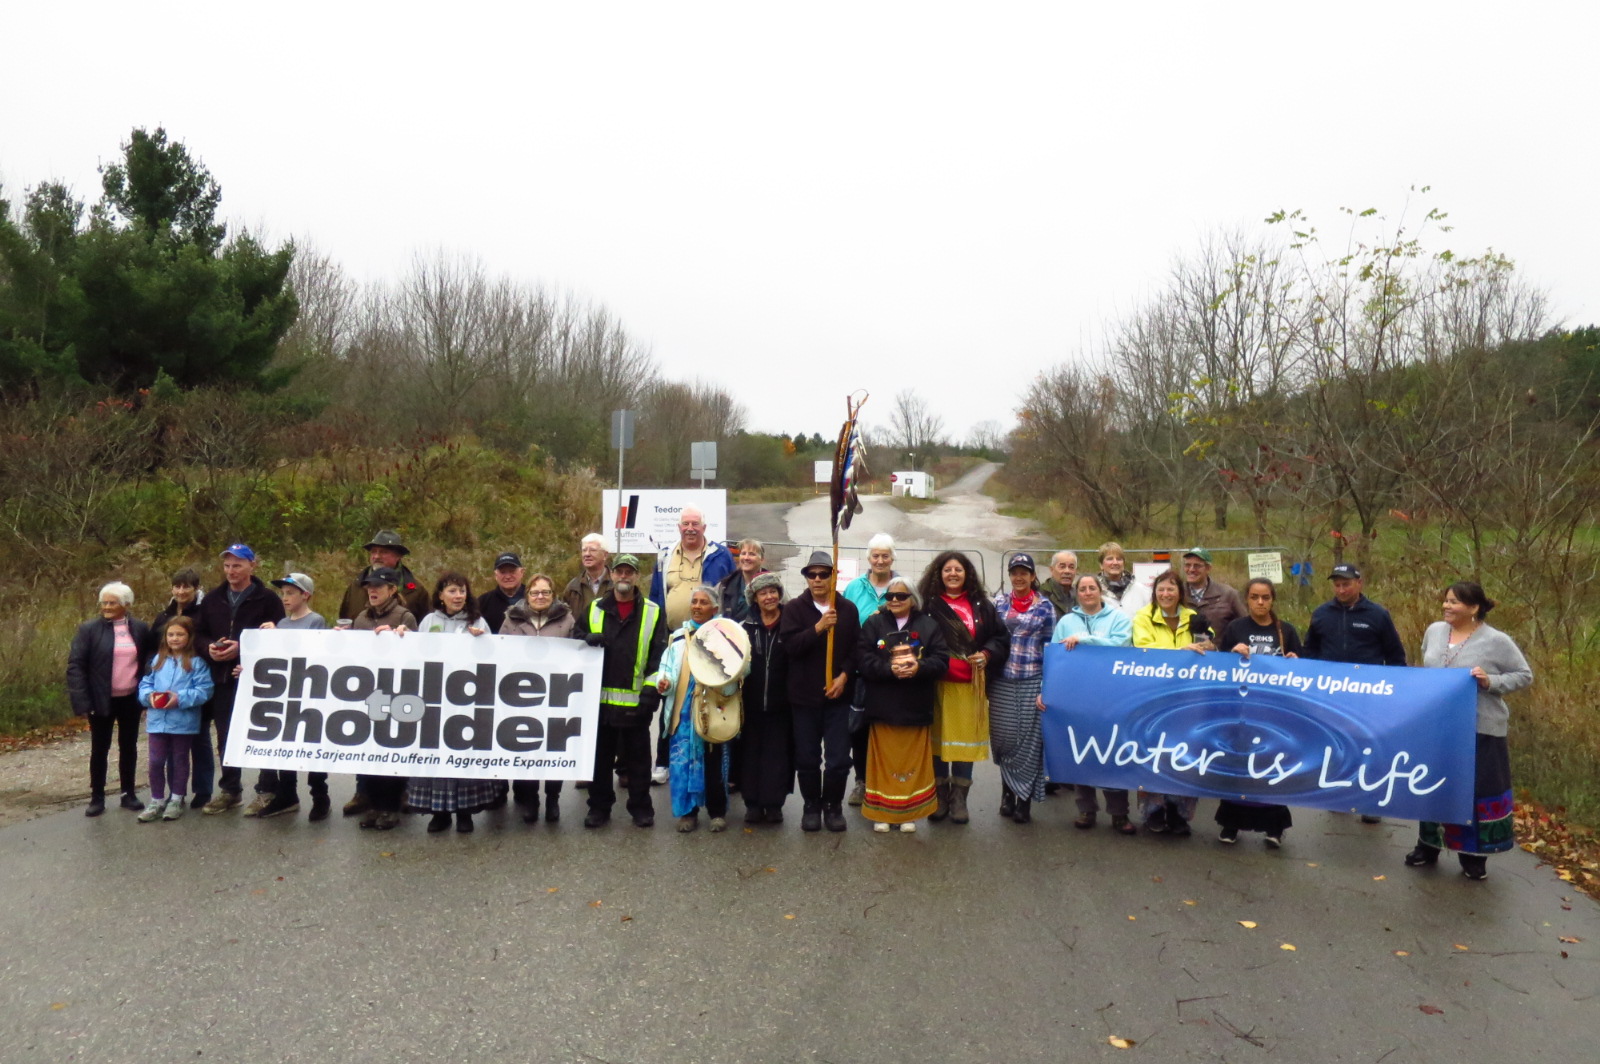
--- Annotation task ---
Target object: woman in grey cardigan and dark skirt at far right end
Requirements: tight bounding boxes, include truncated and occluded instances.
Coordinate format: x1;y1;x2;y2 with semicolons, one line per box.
1405;581;1533;880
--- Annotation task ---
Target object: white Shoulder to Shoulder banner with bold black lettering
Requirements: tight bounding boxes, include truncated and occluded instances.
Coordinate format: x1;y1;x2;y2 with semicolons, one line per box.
224;629;603;779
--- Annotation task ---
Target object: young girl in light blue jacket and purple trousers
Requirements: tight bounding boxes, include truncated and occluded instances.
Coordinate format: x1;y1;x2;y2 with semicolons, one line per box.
138;616;213;824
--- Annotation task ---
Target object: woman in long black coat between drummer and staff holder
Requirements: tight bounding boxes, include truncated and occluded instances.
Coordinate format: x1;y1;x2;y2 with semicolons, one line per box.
739;573;795;824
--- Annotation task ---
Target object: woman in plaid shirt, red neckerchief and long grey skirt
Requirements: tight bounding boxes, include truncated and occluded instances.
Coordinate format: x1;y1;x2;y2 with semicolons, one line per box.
989;554;1056;824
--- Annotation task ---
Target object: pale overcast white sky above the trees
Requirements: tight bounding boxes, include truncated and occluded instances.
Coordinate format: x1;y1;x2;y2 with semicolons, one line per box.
0;0;1600;437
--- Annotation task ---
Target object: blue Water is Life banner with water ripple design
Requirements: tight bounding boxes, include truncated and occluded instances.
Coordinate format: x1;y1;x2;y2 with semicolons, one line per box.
1042;643;1477;824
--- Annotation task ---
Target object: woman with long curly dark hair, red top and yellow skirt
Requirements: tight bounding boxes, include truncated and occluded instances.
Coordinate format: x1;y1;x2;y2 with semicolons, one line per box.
917;550;1011;824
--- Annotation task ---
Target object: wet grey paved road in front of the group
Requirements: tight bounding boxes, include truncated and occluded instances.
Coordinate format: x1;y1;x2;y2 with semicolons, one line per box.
0;480;1600;1064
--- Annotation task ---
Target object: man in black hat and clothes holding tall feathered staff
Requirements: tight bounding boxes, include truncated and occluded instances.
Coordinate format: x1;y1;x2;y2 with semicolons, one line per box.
778;550;861;832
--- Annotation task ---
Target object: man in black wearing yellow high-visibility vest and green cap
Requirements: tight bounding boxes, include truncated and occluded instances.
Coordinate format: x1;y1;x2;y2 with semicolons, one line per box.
579;554;667;827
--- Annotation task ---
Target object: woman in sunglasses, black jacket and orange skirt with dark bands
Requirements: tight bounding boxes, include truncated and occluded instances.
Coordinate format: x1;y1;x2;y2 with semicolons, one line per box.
856;576;950;832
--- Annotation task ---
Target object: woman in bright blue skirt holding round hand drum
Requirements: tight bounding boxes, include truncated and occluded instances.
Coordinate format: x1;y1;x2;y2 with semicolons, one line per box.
656;584;733;832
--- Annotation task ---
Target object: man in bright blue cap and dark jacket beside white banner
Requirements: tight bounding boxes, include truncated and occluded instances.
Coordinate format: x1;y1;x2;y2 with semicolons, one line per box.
194;542;283;813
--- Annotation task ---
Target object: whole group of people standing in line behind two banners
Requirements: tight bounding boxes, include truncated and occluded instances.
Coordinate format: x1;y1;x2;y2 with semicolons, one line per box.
67;509;1533;880
